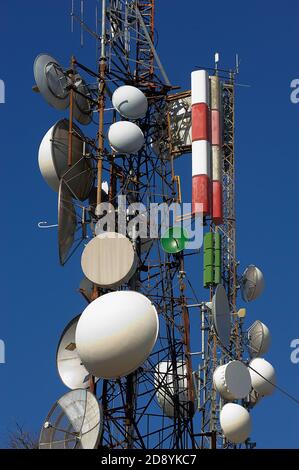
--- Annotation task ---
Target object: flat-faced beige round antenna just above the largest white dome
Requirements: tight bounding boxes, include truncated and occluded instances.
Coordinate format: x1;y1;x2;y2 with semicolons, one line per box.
81;232;137;289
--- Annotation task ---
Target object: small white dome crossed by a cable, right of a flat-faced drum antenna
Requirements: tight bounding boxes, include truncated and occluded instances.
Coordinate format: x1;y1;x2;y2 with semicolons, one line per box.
249;357;276;396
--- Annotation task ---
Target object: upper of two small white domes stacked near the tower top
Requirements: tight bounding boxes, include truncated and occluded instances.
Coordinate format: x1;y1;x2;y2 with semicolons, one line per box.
112;85;148;119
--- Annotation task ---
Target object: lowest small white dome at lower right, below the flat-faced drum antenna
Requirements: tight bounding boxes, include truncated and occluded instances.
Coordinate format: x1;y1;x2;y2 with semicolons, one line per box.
220;403;251;444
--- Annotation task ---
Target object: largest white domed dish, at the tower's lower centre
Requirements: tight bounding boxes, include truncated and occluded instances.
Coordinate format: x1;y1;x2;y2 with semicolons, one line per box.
76;291;159;379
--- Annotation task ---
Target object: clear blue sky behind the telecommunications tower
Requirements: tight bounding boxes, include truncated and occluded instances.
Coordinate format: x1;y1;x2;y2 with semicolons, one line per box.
0;0;299;448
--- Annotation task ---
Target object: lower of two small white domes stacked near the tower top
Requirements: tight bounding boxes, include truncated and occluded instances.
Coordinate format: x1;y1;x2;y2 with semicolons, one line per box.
108;121;144;154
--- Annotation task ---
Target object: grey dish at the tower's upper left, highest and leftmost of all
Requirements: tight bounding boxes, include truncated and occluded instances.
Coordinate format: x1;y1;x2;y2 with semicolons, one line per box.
33;54;69;109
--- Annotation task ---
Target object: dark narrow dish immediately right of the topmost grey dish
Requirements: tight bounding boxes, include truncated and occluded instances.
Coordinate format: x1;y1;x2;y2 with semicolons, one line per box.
73;74;92;126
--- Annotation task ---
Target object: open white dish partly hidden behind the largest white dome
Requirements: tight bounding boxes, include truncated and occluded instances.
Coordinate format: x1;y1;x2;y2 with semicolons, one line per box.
56;315;98;390
